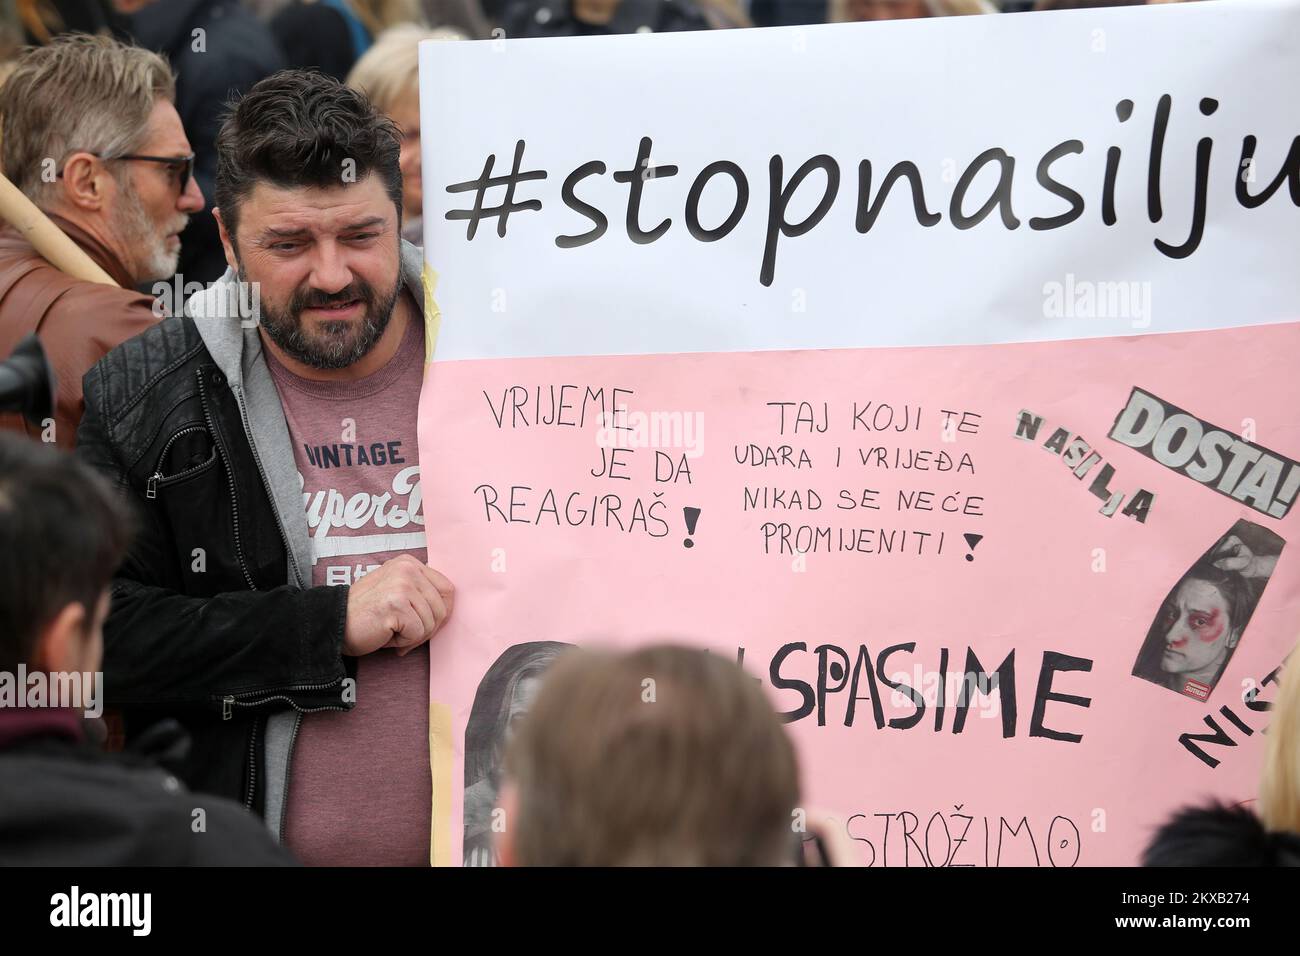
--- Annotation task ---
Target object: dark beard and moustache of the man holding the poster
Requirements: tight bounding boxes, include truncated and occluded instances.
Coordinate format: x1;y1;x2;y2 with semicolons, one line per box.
239;263;402;369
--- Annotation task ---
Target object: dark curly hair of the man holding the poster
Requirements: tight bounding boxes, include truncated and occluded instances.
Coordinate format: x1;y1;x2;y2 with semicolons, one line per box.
215;70;402;238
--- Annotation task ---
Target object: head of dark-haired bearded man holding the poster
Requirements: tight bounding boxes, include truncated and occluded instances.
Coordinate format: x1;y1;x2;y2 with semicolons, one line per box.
213;70;402;371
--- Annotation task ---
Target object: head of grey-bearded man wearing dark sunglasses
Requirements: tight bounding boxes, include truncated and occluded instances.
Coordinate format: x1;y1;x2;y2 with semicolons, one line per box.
0;34;203;286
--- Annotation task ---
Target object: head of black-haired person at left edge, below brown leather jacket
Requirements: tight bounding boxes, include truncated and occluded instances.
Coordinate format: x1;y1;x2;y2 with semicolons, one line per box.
0;433;130;674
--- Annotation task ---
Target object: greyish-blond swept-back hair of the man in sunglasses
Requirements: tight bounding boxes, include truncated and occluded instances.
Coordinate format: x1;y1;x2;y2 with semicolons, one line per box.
0;34;176;206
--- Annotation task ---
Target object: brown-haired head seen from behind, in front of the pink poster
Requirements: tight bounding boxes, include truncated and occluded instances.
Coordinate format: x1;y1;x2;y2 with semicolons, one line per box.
497;646;800;866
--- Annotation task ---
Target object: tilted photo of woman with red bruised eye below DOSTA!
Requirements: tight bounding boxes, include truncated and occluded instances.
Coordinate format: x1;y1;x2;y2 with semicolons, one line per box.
1132;520;1284;701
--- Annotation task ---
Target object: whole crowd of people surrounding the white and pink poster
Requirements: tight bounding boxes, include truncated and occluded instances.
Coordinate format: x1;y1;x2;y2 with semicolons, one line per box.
0;0;1284;865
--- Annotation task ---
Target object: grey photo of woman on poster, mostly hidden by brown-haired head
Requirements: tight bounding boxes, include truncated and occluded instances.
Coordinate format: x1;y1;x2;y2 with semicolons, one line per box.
462;641;572;866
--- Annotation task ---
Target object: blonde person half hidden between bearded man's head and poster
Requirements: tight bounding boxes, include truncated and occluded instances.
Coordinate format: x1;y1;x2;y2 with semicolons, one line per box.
347;23;465;246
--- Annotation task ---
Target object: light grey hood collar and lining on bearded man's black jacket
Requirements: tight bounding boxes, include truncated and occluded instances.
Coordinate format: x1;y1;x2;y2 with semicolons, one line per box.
185;239;425;588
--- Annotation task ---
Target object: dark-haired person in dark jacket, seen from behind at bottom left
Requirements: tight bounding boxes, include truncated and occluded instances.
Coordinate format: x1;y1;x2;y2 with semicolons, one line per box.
0;433;293;866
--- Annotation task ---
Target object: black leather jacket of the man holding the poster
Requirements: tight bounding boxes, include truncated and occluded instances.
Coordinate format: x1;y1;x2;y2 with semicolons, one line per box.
77;317;355;813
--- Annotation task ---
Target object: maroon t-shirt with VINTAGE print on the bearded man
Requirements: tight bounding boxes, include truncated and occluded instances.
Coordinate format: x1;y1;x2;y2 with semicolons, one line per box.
267;312;432;866
